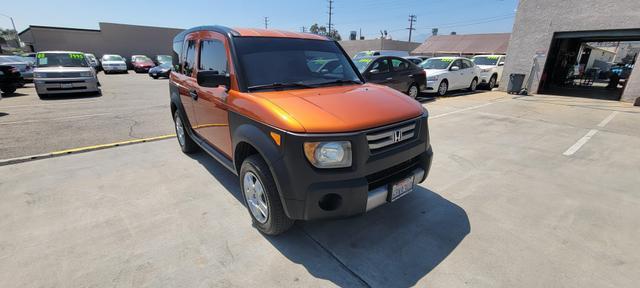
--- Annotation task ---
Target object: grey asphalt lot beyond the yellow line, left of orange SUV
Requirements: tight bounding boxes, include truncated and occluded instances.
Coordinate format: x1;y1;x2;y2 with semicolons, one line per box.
0;71;174;159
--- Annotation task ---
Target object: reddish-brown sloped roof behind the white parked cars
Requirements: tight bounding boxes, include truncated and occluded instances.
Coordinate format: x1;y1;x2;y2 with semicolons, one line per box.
412;33;511;54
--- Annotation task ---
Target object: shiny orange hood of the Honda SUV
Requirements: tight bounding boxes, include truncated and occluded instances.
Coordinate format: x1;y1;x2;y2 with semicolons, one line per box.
252;84;423;133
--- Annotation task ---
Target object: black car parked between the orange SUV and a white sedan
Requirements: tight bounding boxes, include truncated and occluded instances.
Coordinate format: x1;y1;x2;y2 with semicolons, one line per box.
353;56;427;99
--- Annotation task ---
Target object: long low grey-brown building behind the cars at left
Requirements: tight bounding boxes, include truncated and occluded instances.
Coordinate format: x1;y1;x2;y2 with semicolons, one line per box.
19;23;182;62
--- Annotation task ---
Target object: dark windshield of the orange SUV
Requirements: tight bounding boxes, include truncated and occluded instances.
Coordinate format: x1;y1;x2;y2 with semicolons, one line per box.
234;37;360;89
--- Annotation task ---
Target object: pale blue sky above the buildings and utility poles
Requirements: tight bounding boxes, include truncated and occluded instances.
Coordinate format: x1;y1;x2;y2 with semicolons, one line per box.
0;0;518;40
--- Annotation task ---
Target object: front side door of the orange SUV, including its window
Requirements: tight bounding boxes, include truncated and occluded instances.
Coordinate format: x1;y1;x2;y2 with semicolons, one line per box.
193;31;233;158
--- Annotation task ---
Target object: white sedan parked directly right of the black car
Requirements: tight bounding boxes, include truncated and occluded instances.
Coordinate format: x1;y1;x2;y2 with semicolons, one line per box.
420;57;480;96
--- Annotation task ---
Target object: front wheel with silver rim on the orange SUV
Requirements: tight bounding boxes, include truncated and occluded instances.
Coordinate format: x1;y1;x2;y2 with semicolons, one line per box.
239;154;295;235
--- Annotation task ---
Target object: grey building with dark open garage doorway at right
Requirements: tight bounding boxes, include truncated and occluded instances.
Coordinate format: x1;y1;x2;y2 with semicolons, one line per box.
501;0;640;102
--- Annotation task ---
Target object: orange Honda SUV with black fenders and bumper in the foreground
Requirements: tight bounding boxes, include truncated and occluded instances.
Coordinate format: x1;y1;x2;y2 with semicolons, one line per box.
169;26;433;235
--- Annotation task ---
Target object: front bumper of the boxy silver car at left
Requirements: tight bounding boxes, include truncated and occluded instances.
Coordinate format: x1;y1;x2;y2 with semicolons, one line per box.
33;77;98;94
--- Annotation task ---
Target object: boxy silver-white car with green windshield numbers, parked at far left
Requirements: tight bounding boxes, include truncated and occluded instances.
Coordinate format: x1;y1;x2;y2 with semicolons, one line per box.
33;51;100;99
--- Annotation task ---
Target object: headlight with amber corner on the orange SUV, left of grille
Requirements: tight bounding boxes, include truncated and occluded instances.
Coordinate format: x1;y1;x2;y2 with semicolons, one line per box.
304;141;352;168
